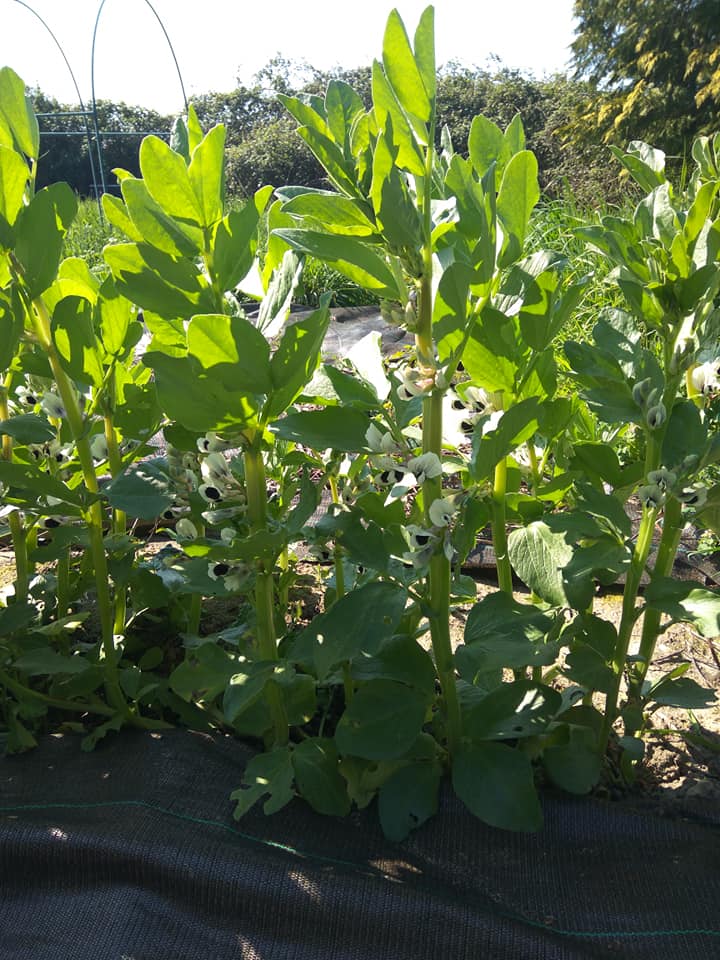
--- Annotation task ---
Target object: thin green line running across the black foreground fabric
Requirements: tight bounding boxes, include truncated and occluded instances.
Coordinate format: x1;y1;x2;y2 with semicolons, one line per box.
0;800;720;940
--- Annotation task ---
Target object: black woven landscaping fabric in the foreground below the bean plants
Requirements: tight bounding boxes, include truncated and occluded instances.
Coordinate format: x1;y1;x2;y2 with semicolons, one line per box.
0;731;720;960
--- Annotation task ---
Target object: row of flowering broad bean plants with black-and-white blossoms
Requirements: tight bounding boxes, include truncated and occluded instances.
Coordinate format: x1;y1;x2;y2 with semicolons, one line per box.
0;7;720;839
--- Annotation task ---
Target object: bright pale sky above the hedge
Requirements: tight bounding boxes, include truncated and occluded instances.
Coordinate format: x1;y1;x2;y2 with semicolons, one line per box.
0;0;573;113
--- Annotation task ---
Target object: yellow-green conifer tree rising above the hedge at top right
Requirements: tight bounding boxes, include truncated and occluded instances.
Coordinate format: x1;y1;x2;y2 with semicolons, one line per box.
572;0;720;154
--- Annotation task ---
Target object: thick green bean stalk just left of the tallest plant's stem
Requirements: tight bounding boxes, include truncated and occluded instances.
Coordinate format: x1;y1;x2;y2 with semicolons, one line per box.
243;436;289;746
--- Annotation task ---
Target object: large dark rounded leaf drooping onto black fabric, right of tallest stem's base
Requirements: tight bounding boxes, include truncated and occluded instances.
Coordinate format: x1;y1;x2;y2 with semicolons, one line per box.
452;743;542;831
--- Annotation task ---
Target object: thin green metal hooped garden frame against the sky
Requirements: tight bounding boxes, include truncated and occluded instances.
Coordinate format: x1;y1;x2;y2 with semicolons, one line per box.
7;0;188;207
